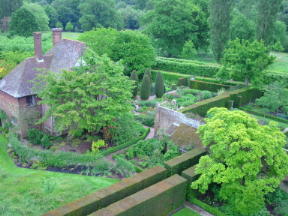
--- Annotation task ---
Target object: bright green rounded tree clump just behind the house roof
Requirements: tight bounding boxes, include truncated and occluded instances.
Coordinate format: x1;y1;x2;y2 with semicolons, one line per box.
80;28;155;75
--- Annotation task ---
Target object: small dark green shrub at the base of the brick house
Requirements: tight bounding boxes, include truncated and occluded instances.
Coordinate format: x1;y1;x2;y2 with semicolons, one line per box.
27;128;53;149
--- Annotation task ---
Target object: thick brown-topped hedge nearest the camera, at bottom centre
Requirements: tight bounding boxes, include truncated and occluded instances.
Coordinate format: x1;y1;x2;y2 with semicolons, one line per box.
91;175;187;216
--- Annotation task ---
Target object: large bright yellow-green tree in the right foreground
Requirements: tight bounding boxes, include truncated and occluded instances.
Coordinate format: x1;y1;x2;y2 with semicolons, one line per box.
192;108;288;216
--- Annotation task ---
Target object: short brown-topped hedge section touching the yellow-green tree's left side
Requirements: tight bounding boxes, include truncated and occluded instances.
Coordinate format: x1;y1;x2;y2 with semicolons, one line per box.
164;148;207;175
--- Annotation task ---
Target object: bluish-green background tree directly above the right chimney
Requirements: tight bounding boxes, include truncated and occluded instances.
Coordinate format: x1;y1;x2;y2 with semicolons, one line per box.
52;0;80;30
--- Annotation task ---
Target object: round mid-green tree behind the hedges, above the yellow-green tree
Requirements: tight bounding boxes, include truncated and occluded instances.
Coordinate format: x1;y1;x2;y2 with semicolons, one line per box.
218;39;274;86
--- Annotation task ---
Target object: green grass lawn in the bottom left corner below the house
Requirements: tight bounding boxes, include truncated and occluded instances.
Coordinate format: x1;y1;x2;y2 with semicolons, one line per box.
0;135;118;216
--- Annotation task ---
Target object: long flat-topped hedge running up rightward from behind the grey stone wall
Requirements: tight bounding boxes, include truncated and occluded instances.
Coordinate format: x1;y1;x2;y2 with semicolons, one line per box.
180;88;263;117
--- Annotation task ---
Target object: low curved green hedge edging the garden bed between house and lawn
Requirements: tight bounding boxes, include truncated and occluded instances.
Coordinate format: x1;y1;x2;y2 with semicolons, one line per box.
9;128;150;168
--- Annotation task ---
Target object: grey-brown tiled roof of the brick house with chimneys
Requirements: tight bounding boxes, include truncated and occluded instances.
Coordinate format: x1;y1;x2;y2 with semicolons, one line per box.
0;39;85;98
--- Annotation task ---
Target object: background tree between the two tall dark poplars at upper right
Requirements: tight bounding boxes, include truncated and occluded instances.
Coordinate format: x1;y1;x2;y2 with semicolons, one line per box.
231;10;256;40
